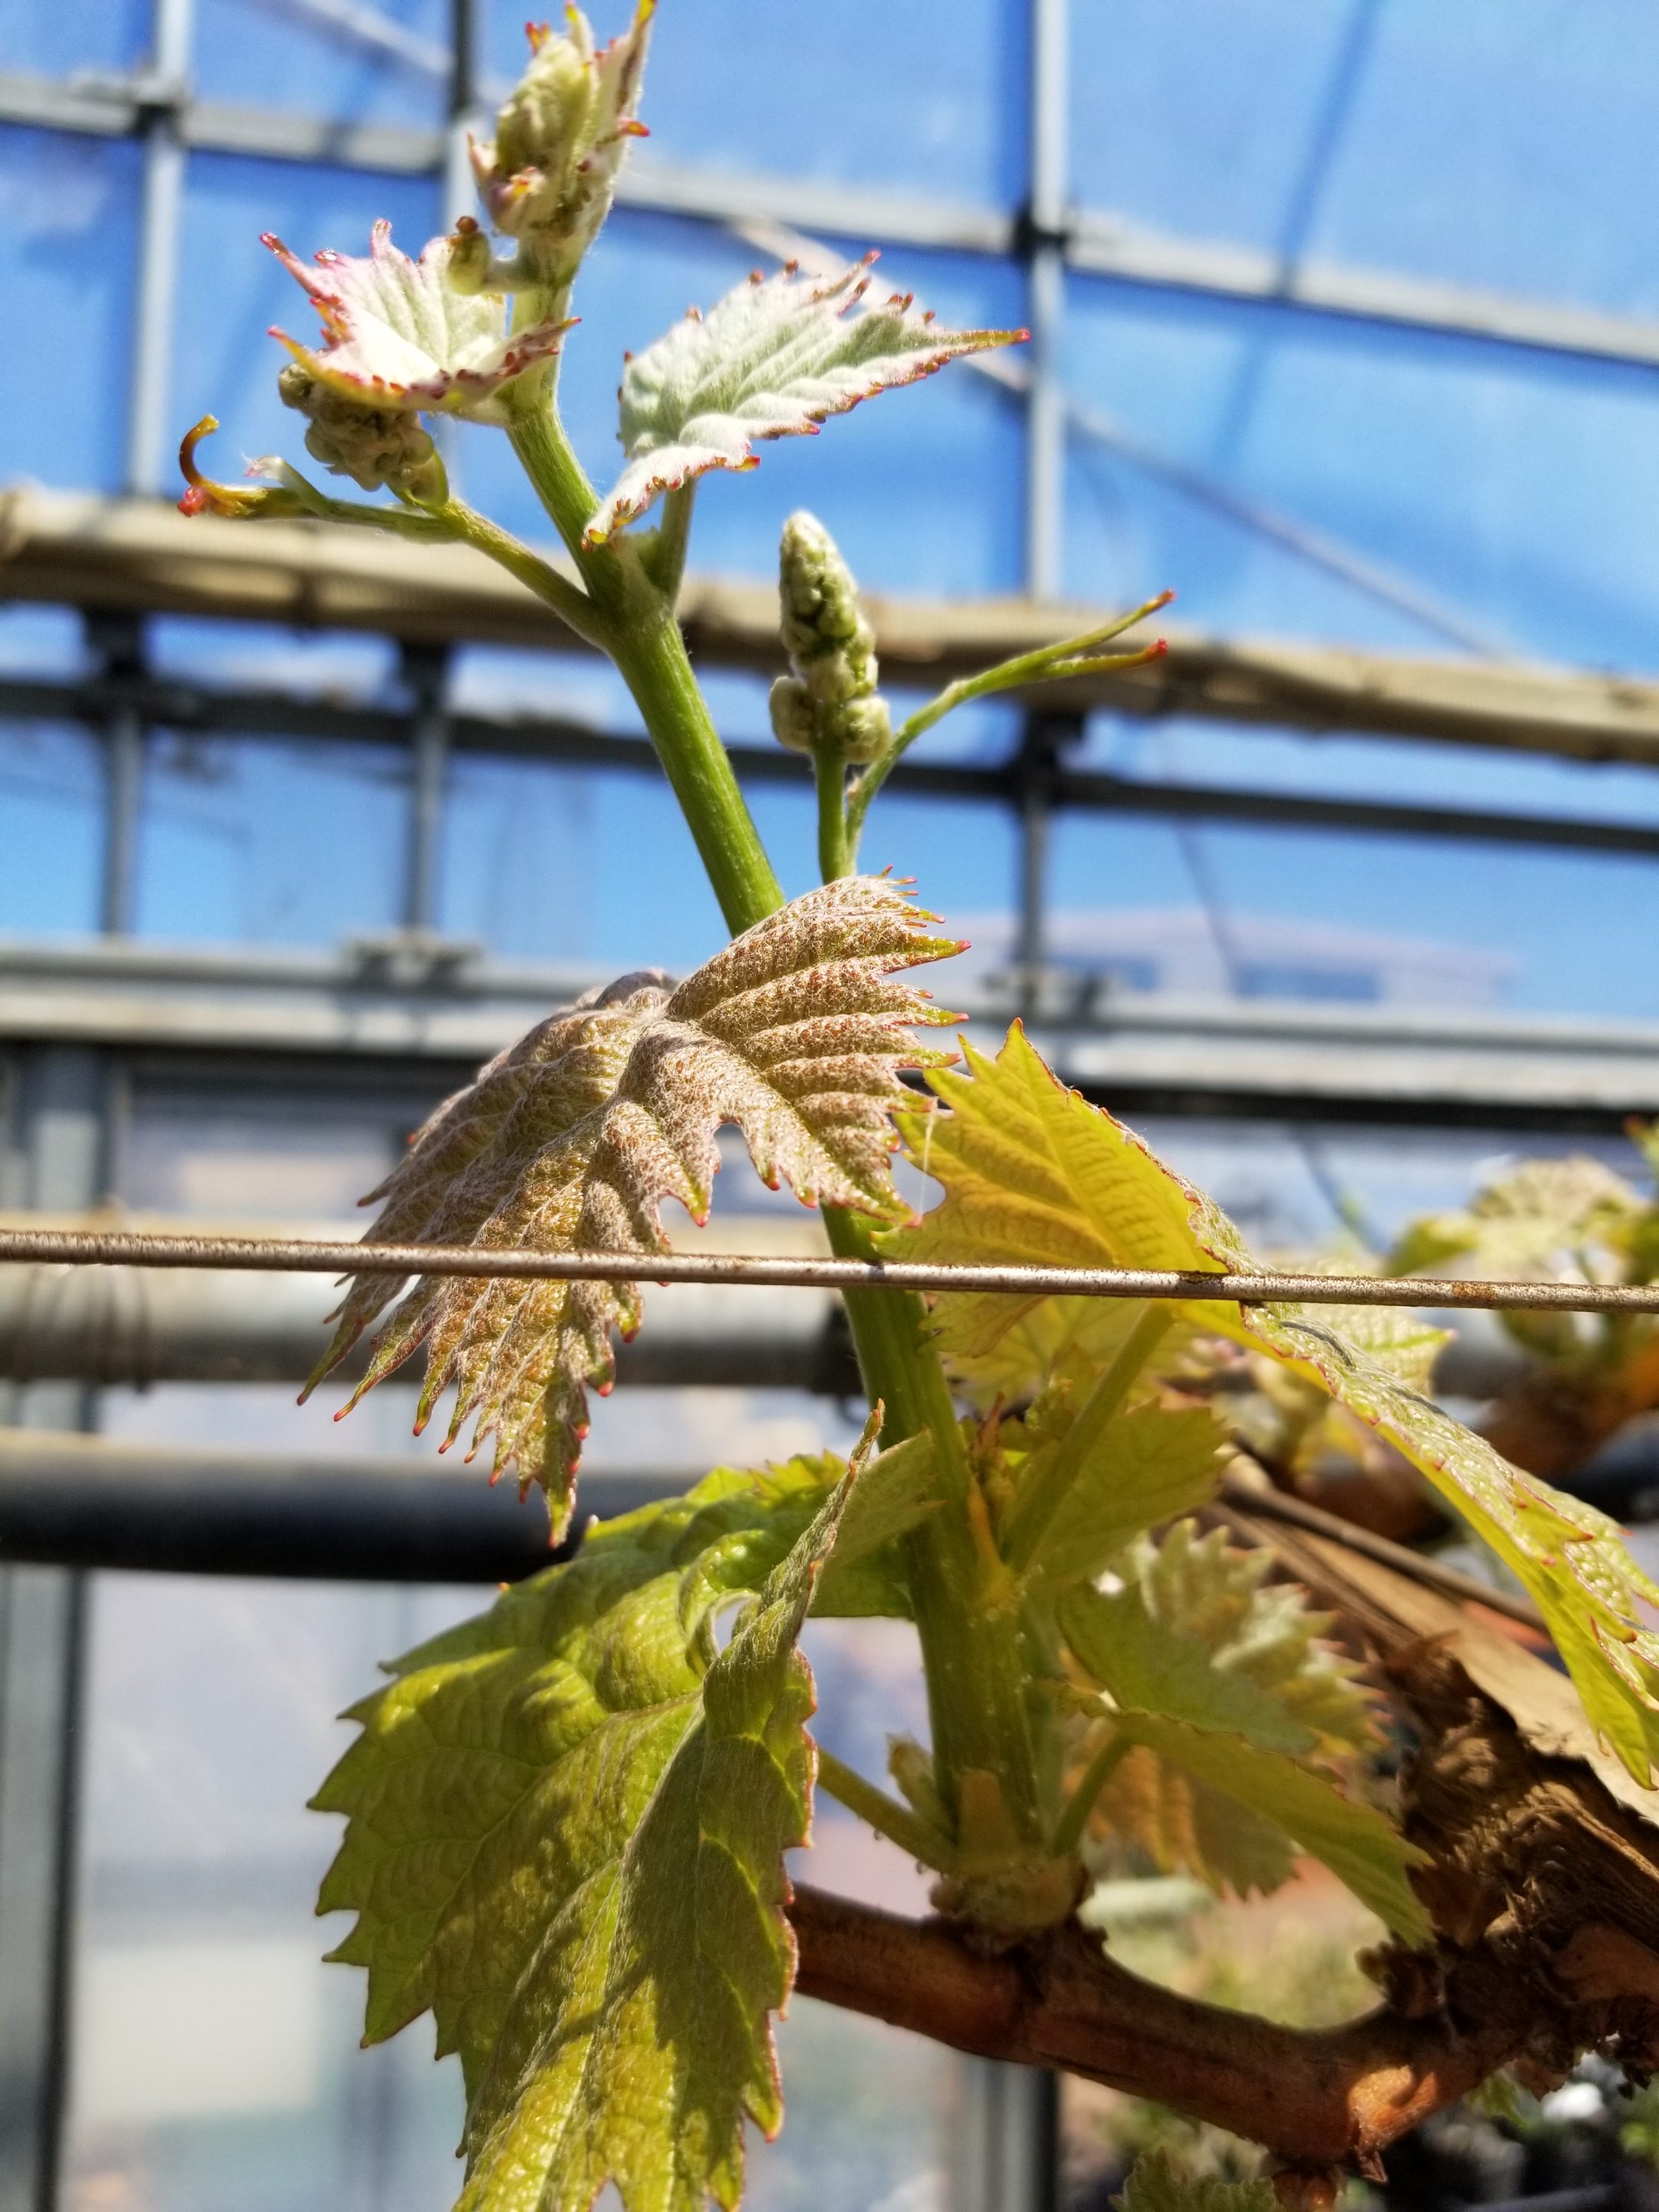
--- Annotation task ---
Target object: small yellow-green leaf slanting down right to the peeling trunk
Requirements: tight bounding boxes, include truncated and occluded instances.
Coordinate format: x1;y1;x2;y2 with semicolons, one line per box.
1060;1584;1429;1938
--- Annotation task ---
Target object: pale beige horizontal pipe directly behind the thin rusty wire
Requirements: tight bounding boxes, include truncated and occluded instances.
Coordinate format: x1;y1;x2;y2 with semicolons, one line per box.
0;1214;858;1396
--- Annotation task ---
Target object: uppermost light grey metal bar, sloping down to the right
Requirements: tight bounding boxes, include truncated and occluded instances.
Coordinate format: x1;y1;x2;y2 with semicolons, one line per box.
0;71;1659;369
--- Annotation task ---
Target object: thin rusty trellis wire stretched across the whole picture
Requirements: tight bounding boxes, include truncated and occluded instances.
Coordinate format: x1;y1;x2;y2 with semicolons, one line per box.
0;1227;1659;1314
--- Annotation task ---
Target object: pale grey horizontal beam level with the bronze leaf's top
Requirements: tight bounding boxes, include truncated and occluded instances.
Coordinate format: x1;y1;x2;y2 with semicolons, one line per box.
0;938;1659;1134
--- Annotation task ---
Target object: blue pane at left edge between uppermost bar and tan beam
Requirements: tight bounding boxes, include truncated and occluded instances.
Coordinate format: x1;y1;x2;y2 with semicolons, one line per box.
0;127;139;491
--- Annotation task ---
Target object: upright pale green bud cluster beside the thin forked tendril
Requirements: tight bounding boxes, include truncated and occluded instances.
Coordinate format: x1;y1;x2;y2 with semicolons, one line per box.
772;513;892;765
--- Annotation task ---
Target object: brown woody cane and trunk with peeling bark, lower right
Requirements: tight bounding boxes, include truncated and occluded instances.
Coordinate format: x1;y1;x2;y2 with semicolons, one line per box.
790;1511;1659;2201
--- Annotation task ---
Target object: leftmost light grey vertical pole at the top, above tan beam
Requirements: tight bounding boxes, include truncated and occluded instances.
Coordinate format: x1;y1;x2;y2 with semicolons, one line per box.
126;0;194;493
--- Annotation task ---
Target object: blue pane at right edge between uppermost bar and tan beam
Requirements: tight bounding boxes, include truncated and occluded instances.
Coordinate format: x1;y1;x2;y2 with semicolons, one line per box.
1068;270;1659;668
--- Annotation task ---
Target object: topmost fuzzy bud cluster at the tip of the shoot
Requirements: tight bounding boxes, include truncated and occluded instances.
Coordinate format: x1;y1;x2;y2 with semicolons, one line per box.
471;0;654;283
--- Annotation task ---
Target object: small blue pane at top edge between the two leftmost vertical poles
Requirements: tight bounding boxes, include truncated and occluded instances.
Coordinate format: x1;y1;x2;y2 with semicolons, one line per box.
197;0;449;124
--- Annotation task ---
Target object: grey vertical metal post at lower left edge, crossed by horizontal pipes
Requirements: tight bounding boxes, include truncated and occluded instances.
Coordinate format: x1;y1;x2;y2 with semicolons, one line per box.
0;1046;108;2212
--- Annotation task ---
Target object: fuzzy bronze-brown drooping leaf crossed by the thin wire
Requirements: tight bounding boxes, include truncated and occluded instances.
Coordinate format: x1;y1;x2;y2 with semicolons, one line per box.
312;876;960;1535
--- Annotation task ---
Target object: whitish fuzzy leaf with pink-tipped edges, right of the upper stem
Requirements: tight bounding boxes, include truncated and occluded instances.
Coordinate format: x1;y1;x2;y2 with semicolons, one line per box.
586;261;1024;544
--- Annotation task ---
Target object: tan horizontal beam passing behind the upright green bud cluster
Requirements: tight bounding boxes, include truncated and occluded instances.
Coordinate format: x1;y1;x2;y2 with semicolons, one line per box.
0;491;1659;765
